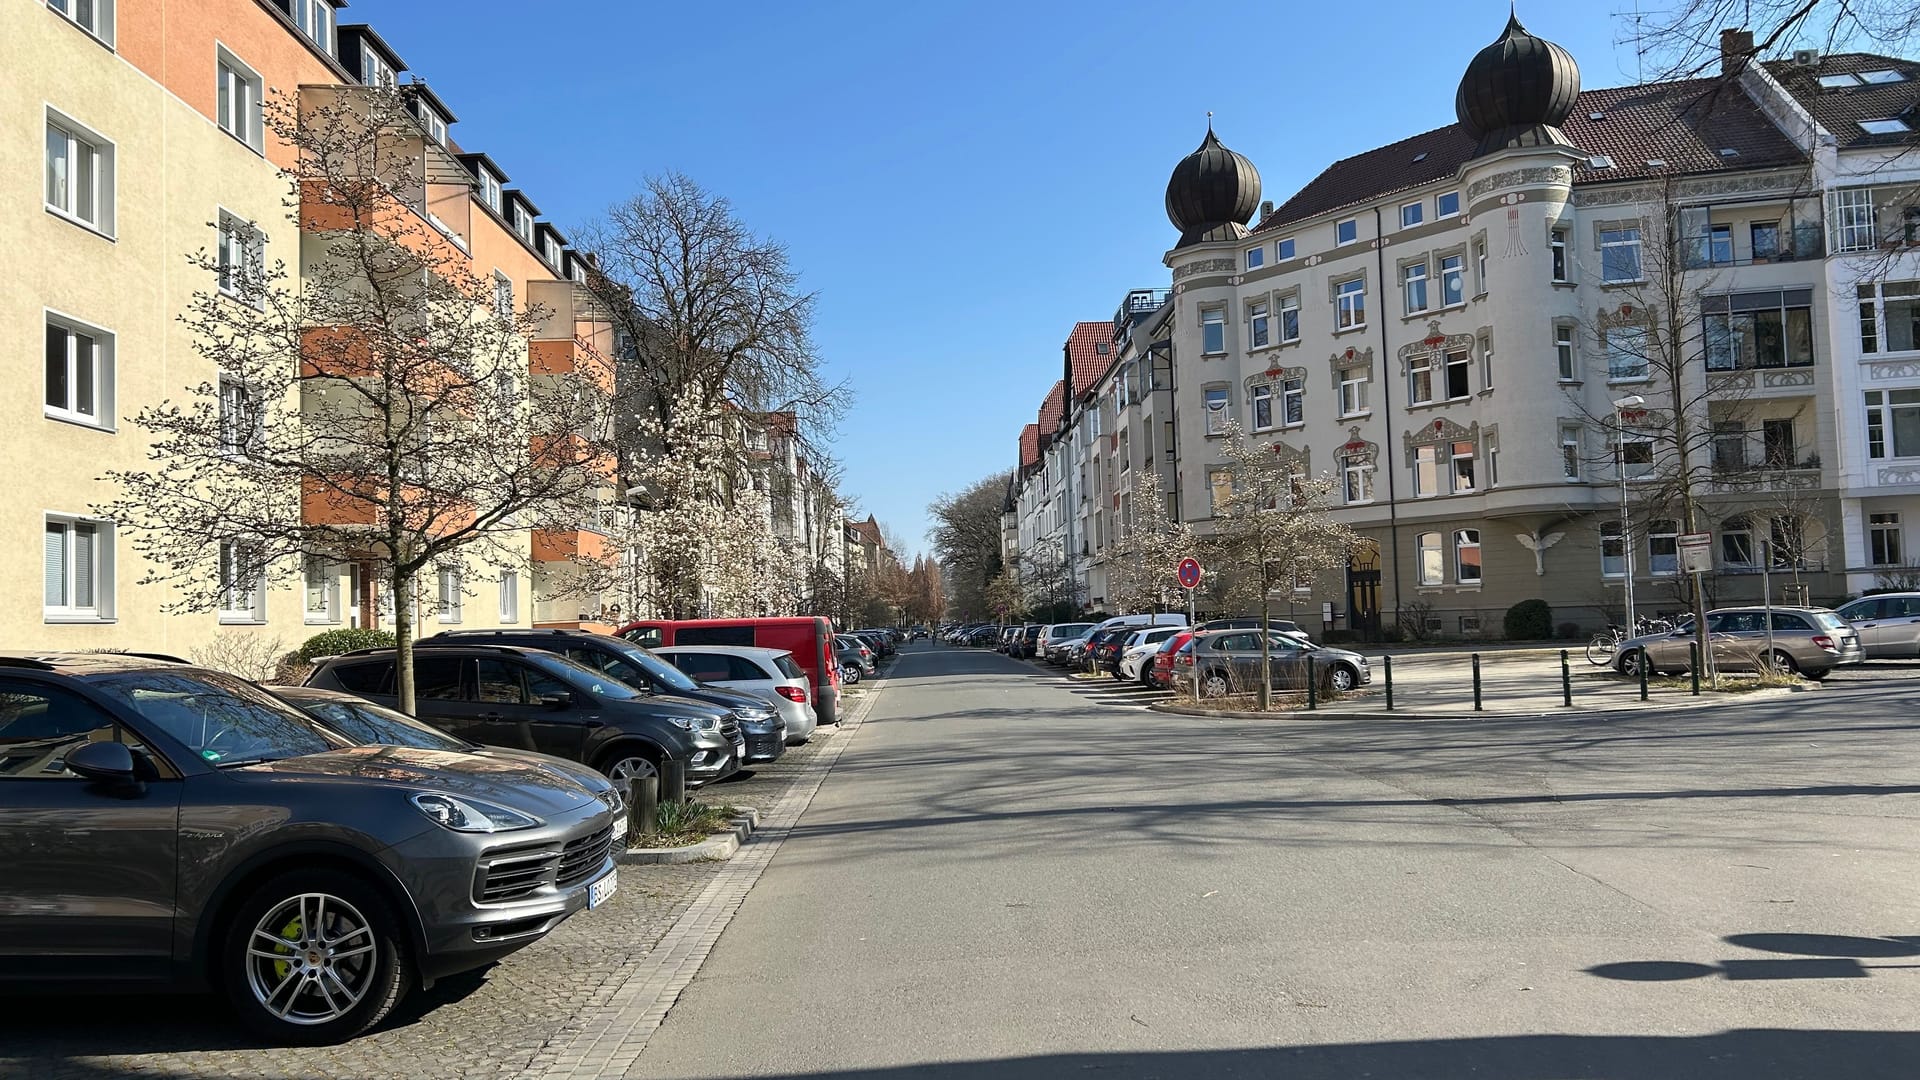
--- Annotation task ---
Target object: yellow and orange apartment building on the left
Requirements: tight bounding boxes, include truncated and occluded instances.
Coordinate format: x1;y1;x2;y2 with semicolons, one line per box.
0;0;614;653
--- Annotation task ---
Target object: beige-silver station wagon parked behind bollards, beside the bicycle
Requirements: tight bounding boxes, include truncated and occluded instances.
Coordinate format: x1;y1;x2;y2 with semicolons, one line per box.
1613;607;1866;678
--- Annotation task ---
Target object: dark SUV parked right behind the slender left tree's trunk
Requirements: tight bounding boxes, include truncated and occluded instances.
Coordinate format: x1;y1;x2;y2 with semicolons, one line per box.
307;646;747;786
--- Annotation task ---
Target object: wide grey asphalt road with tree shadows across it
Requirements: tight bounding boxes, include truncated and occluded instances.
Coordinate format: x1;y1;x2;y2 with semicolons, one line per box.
634;646;1920;1080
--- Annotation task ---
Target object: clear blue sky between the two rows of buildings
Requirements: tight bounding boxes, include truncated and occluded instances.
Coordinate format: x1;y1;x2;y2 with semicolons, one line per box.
342;0;1634;552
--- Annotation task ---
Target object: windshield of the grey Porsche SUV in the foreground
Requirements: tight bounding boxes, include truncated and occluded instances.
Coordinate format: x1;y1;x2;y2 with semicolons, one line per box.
88;667;351;767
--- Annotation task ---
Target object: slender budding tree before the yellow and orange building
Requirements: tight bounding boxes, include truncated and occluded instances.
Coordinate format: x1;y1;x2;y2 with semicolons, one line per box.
98;88;612;711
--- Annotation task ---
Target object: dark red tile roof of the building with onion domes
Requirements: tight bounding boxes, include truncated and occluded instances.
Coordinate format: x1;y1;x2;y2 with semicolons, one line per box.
1254;79;1805;233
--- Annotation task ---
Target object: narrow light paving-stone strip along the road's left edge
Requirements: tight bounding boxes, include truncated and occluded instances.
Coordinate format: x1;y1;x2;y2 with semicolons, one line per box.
528;661;887;1080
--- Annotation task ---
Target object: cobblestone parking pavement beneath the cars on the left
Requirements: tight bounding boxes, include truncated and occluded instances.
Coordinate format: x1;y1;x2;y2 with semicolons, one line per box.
0;664;883;1080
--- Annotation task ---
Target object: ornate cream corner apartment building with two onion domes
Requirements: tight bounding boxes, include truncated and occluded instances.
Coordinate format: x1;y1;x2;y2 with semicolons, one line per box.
1165;19;1896;636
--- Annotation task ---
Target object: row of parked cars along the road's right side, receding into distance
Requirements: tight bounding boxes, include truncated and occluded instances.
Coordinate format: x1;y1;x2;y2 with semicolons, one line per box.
943;615;1373;698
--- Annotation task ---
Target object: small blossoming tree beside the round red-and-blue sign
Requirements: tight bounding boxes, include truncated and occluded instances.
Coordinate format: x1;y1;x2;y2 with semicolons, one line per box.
1204;421;1359;711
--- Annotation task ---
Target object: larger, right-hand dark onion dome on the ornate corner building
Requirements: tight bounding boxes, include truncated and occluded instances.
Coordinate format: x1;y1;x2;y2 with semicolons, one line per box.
1451;13;1580;157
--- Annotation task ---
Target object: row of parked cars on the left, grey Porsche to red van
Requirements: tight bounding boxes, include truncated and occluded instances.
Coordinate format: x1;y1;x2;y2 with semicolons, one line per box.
0;619;898;1043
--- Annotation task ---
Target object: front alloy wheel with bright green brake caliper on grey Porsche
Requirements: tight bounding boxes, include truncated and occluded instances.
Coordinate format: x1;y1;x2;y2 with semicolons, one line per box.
246;892;380;1026
